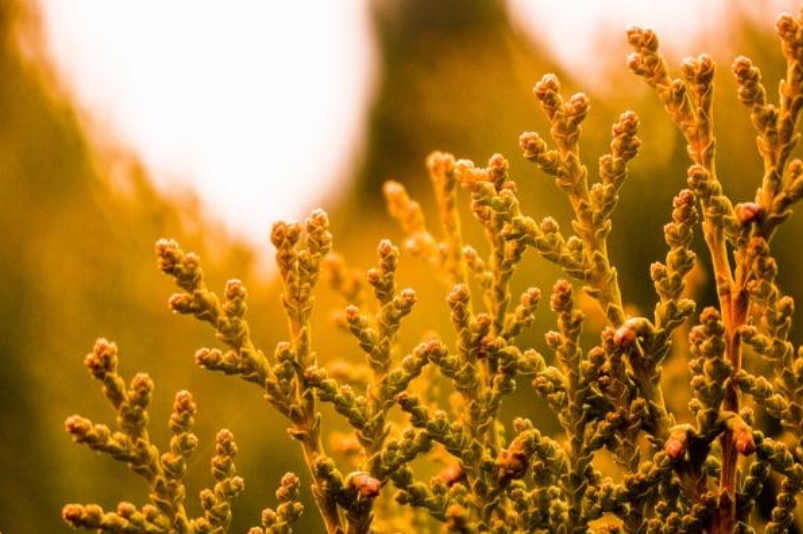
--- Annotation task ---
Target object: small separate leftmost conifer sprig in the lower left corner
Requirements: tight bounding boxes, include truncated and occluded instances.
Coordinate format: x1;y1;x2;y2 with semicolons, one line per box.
62;339;243;534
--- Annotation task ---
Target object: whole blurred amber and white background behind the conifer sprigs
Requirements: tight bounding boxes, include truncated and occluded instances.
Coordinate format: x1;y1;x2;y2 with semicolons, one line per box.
0;0;803;534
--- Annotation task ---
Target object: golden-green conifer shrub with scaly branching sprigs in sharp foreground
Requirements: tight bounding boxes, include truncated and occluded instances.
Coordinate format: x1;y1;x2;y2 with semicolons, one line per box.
63;5;803;534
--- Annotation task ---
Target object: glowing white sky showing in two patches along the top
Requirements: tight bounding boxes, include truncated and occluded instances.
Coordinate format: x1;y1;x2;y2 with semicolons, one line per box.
39;0;798;245
